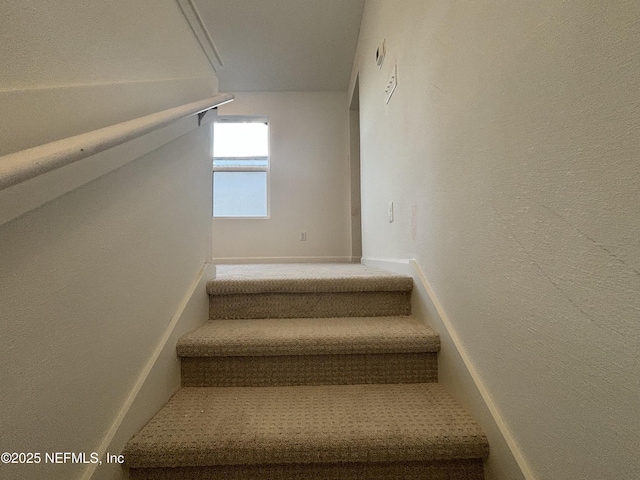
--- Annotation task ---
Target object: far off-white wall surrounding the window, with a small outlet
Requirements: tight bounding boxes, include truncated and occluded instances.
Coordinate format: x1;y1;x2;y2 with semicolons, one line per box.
213;92;351;261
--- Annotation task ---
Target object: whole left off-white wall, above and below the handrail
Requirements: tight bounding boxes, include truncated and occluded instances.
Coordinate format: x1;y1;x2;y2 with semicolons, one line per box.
0;0;217;480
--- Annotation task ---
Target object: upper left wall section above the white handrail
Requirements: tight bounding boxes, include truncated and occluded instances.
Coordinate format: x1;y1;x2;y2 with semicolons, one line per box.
0;0;217;155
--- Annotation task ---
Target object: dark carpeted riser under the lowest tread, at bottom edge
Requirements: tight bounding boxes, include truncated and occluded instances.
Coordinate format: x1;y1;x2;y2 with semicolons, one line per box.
130;460;484;480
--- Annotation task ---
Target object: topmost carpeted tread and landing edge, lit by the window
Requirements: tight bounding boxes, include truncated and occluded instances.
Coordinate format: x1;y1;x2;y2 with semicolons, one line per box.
207;264;413;295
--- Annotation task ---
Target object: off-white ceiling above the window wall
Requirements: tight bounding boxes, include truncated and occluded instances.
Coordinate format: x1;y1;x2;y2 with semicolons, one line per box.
195;0;364;92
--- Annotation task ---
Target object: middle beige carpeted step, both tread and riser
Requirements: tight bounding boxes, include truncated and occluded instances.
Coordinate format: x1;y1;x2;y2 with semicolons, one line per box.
178;316;440;387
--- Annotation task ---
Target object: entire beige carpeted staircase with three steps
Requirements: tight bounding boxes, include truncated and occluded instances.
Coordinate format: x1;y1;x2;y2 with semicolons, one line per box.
124;264;489;480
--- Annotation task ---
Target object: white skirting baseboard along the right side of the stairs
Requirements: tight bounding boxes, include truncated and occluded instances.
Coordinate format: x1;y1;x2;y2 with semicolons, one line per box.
362;258;536;480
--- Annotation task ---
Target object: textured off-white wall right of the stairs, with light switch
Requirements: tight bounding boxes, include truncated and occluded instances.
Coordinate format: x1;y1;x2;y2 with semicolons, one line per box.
352;0;640;479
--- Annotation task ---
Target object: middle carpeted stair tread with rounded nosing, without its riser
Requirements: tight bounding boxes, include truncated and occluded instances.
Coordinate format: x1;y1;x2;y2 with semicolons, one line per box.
177;316;440;357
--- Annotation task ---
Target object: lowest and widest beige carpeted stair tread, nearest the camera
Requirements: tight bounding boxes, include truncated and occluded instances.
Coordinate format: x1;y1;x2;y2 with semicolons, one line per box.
125;383;489;468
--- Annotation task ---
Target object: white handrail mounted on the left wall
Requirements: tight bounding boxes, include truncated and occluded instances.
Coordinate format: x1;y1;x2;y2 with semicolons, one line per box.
0;94;234;190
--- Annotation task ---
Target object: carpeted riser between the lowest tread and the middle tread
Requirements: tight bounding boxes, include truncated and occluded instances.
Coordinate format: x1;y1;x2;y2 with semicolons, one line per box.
182;352;438;387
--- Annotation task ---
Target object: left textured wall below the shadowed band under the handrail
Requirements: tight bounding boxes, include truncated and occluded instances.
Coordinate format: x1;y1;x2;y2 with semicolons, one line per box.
0;124;211;479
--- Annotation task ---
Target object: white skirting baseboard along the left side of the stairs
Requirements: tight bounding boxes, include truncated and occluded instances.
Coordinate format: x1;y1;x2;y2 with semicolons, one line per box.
81;263;215;480
